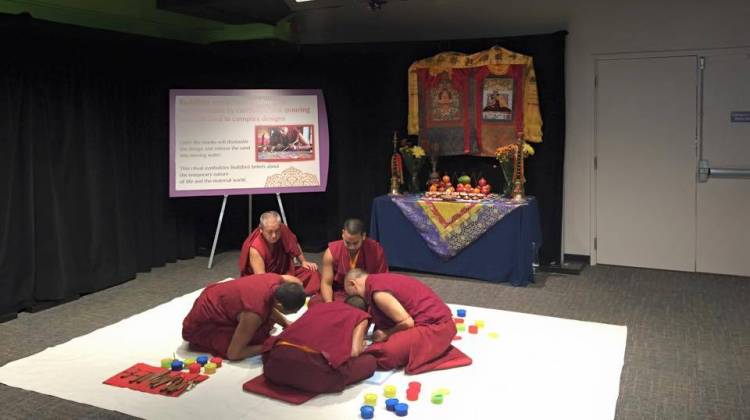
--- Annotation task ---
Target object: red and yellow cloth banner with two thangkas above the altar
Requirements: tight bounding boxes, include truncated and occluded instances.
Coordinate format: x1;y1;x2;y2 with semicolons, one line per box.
408;47;542;157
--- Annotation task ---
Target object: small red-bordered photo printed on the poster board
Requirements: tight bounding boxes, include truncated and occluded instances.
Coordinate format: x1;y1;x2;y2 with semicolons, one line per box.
255;124;315;162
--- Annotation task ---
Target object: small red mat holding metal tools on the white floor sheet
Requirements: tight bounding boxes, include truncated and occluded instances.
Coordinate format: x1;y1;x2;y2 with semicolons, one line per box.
103;363;208;397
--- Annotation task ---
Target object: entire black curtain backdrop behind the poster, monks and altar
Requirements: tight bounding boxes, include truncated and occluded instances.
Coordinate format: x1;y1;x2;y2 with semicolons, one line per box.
0;15;565;315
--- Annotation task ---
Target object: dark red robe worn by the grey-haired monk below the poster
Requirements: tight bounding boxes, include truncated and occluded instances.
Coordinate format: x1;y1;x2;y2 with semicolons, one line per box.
239;223;320;295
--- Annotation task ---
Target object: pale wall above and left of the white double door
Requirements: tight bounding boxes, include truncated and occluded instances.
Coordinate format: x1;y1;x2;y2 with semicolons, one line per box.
296;0;750;255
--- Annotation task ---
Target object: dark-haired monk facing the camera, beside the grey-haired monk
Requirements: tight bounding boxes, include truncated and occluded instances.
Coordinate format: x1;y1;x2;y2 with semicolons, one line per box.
309;219;388;305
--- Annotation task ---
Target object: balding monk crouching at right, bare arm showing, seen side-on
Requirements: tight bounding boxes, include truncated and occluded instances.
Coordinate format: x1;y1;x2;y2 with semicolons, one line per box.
345;268;471;374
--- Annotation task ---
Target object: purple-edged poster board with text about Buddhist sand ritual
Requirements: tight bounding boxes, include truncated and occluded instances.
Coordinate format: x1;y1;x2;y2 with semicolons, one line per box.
169;89;328;197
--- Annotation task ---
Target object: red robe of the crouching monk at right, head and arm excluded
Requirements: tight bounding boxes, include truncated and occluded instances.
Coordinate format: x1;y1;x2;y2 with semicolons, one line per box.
365;273;471;374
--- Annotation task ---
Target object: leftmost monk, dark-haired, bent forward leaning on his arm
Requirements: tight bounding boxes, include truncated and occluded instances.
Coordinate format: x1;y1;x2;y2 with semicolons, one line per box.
182;273;305;360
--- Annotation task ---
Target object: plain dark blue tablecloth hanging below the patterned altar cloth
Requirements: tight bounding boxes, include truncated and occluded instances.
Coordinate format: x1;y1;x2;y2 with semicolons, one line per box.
370;195;542;286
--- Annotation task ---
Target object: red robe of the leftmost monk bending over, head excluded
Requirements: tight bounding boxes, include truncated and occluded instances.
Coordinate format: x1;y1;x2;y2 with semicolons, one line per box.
182;273;283;358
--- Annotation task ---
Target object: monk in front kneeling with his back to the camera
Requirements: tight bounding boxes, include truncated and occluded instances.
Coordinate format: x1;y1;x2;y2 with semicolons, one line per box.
263;296;377;393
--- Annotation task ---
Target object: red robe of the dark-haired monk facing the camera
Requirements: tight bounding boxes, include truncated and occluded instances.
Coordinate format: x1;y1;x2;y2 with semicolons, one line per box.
309;238;388;305
